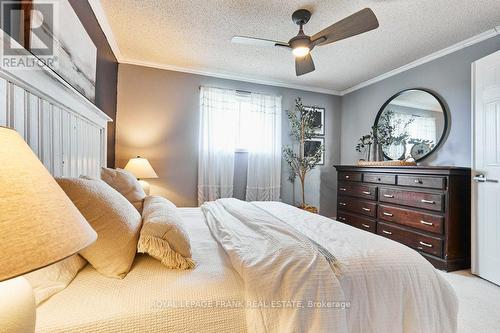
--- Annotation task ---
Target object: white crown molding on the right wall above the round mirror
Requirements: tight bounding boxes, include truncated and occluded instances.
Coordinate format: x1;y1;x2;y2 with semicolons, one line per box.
340;26;500;96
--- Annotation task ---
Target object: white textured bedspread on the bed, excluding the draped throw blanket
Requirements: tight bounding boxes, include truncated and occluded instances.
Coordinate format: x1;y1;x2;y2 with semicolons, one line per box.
37;202;458;332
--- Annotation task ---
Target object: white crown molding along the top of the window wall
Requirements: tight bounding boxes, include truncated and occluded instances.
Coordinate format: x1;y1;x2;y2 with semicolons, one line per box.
120;59;340;96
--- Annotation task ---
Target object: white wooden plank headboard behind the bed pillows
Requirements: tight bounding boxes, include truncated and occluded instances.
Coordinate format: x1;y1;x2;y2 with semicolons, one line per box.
0;35;111;177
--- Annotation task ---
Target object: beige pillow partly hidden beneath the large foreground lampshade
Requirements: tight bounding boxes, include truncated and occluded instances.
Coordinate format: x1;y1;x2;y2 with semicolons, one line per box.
24;254;87;306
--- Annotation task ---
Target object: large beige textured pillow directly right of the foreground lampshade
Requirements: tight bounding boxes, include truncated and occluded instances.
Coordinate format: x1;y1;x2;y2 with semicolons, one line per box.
56;178;141;278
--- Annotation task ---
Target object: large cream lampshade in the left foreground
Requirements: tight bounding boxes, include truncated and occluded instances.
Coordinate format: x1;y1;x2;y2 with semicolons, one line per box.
0;127;97;281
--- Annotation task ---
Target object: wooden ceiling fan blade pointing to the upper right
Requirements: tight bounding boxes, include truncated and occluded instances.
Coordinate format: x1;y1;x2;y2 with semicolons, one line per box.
311;8;378;45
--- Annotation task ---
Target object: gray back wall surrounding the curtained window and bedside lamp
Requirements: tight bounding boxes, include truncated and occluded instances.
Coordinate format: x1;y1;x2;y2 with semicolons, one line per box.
116;64;341;216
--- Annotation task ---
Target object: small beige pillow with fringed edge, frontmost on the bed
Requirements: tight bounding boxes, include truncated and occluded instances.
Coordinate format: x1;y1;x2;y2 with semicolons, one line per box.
141;196;196;269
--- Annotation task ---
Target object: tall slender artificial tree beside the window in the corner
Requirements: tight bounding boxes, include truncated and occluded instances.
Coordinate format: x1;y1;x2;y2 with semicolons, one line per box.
283;97;325;208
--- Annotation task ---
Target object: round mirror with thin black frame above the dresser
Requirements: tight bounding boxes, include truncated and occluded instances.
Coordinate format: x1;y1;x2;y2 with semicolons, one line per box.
374;89;448;161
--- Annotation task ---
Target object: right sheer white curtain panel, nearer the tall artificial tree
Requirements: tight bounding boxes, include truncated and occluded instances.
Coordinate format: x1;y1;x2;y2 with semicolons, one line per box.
245;94;281;201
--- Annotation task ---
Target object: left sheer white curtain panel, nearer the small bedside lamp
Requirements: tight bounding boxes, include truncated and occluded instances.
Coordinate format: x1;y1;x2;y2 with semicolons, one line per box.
198;87;238;205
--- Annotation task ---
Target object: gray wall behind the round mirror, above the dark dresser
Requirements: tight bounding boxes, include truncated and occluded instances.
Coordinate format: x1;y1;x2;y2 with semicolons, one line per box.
340;36;500;166
